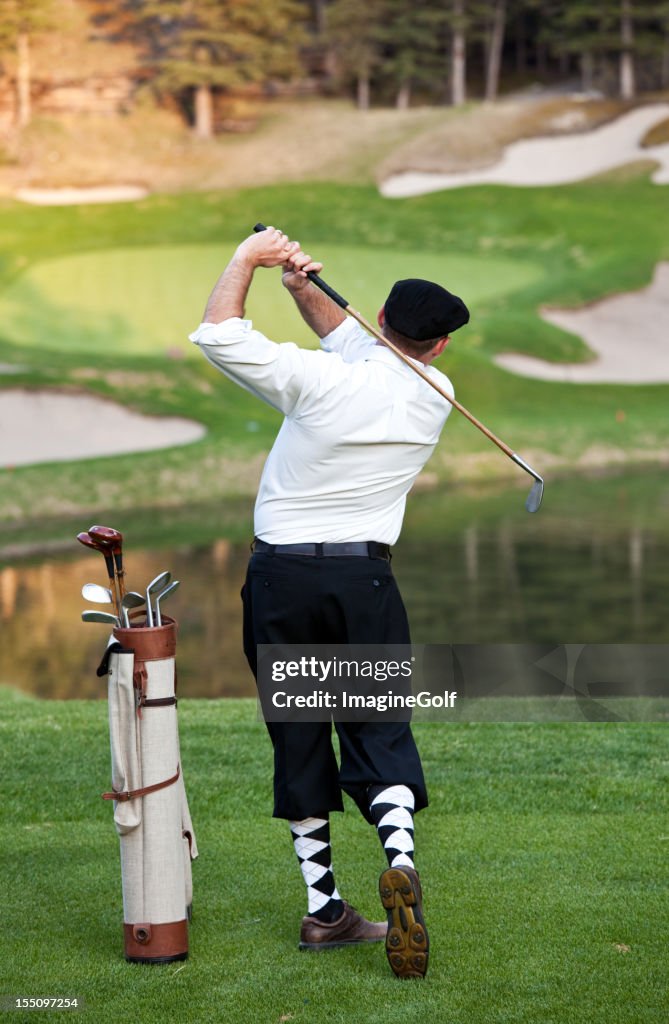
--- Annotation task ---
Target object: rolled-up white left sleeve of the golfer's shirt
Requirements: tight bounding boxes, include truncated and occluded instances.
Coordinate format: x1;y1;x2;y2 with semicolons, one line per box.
189;316;308;416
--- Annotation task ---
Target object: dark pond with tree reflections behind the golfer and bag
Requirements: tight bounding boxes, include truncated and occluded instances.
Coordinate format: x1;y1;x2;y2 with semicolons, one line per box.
0;470;669;698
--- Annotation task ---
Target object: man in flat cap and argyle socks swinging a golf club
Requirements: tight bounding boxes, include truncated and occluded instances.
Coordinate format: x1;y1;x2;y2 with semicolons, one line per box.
191;227;469;978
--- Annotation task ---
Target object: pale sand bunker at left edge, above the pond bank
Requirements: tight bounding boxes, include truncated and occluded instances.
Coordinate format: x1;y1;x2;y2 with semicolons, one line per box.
0;388;206;467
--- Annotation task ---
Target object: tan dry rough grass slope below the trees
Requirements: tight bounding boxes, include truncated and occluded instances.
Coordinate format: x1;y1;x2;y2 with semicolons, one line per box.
0;93;643;195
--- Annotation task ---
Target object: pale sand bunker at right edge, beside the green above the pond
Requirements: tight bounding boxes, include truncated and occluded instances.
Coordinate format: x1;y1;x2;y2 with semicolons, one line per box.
495;263;669;384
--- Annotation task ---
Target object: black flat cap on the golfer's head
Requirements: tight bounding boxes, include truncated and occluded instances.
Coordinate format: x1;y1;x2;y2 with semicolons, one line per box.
385;278;469;341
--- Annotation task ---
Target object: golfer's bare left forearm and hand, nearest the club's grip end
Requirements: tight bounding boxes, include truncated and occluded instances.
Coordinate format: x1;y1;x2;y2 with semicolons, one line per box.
203;227;299;324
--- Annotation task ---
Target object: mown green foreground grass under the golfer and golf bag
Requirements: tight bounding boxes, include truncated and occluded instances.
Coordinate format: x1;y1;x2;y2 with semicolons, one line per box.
0;680;669;1024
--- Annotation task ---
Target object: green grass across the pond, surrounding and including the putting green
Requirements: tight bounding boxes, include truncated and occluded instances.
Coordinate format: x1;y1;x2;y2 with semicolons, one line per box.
0;172;669;522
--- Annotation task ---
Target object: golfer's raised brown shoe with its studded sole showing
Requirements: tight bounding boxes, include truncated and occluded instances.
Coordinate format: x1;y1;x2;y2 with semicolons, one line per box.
379;865;429;978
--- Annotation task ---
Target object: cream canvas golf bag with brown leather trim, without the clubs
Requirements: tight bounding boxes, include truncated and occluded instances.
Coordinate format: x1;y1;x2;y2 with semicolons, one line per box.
98;616;198;964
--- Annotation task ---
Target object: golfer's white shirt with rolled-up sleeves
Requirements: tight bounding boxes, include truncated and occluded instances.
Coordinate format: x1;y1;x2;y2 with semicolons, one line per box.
190;317;453;544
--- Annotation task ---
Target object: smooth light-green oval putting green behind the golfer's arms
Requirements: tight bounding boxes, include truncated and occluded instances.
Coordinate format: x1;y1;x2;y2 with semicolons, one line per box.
0;243;543;354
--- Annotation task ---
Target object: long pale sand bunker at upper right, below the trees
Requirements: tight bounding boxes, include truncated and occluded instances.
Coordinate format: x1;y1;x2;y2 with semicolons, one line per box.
380;103;669;199
